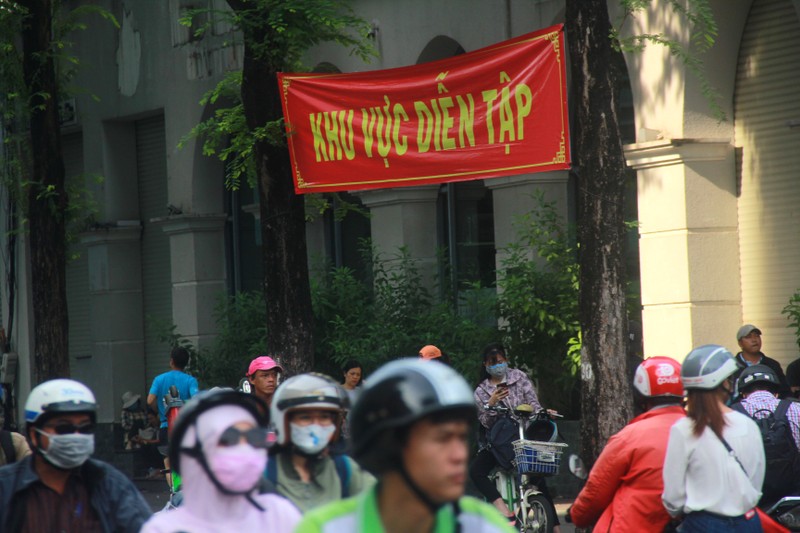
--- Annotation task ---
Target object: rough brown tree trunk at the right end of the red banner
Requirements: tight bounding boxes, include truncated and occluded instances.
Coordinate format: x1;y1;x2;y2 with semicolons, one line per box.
566;0;632;466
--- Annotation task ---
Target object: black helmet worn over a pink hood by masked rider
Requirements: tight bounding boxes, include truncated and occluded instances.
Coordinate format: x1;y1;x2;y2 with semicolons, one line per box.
169;388;269;474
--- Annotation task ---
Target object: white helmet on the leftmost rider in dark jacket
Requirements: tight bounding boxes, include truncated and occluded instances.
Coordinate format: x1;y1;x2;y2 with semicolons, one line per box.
25;379;97;424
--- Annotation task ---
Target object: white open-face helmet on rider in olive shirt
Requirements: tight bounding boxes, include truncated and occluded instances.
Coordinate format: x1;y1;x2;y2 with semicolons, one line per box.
269;372;348;446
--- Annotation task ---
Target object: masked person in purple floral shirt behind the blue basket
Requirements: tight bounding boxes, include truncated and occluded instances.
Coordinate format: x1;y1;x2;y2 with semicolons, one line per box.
469;343;560;533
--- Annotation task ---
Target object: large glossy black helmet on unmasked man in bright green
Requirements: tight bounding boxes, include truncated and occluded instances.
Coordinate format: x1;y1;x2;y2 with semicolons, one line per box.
350;358;477;471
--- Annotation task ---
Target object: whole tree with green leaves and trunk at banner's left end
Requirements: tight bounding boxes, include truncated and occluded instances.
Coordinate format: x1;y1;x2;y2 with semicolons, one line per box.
178;0;372;372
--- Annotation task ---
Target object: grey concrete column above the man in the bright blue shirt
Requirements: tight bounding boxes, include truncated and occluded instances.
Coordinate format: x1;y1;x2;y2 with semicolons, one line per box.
158;214;226;348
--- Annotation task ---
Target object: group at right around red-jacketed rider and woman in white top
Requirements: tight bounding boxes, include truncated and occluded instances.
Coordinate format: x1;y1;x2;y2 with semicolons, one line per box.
568;324;800;533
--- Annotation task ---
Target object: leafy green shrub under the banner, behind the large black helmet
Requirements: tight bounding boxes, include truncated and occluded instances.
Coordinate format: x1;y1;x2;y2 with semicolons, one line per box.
312;245;498;379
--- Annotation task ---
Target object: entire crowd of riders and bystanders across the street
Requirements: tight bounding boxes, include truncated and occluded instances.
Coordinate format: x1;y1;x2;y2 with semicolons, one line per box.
0;325;800;533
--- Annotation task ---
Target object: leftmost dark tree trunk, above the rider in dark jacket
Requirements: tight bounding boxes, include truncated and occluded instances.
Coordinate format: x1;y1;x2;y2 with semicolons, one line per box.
20;0;69;383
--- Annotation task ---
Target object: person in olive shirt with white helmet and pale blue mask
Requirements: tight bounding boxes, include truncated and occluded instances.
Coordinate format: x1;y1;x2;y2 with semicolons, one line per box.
266;373;375;512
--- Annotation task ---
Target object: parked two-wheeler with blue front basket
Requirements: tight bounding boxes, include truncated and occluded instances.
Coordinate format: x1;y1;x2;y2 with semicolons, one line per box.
489;404;568;533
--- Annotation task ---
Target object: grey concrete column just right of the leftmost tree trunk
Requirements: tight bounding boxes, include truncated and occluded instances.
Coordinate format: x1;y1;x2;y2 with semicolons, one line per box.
81;221;147;422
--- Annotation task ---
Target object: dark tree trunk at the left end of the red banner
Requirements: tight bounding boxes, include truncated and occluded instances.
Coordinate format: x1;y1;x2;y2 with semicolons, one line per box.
236;25;314;375
